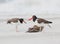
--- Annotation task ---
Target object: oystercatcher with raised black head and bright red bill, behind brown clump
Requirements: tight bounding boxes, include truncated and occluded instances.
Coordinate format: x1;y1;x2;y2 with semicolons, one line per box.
28;15;52;30
